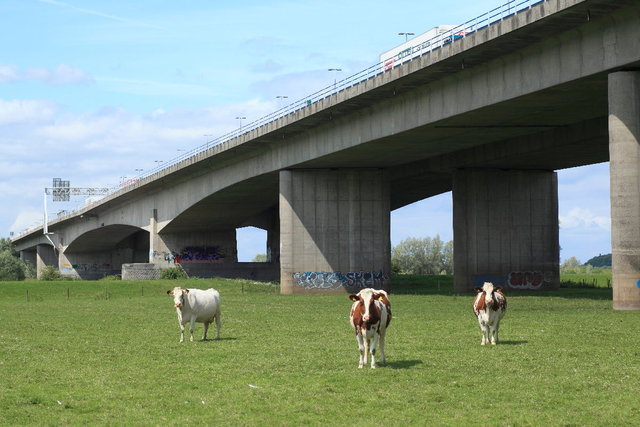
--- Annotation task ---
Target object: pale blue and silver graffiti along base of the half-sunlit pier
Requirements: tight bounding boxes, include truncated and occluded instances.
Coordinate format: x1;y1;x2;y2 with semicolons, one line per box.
293;271;389;289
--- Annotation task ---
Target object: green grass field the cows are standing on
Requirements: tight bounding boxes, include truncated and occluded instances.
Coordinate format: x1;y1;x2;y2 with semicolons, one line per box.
0;278;640;426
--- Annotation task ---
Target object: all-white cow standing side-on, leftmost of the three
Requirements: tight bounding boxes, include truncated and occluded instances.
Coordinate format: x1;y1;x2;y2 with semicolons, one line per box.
167;286;220;342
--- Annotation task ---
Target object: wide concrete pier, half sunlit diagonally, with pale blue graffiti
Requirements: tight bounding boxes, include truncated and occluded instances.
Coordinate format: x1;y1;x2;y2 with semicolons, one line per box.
280;169;391;294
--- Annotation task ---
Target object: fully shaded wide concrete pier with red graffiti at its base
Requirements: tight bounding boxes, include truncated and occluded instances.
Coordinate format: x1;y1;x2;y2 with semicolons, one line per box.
453;169;560;292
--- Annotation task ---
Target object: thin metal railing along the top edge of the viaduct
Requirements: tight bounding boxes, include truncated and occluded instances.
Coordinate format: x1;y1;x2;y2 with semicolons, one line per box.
21;0;548;239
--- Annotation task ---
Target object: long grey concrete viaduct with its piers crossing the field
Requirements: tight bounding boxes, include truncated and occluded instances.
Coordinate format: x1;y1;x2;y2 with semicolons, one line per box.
14;0;640;309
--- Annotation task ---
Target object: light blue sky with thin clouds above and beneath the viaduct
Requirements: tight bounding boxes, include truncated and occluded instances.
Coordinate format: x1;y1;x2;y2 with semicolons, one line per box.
0;0;611;262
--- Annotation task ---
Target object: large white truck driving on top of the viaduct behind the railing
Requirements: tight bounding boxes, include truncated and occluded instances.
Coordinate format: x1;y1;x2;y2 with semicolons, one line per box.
380;25;467;71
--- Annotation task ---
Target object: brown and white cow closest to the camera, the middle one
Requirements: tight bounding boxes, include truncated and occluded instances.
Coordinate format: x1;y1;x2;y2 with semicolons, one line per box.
349;288;391;368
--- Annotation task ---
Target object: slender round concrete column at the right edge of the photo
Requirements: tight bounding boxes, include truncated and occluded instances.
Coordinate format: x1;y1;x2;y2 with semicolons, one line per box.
609;71;640;310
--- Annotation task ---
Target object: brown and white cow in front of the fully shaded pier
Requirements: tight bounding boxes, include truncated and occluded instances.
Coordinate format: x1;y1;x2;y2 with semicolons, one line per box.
473;282;507;345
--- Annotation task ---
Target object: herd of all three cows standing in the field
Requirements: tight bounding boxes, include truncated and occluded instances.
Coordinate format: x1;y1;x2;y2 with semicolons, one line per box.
167;282;507;368
